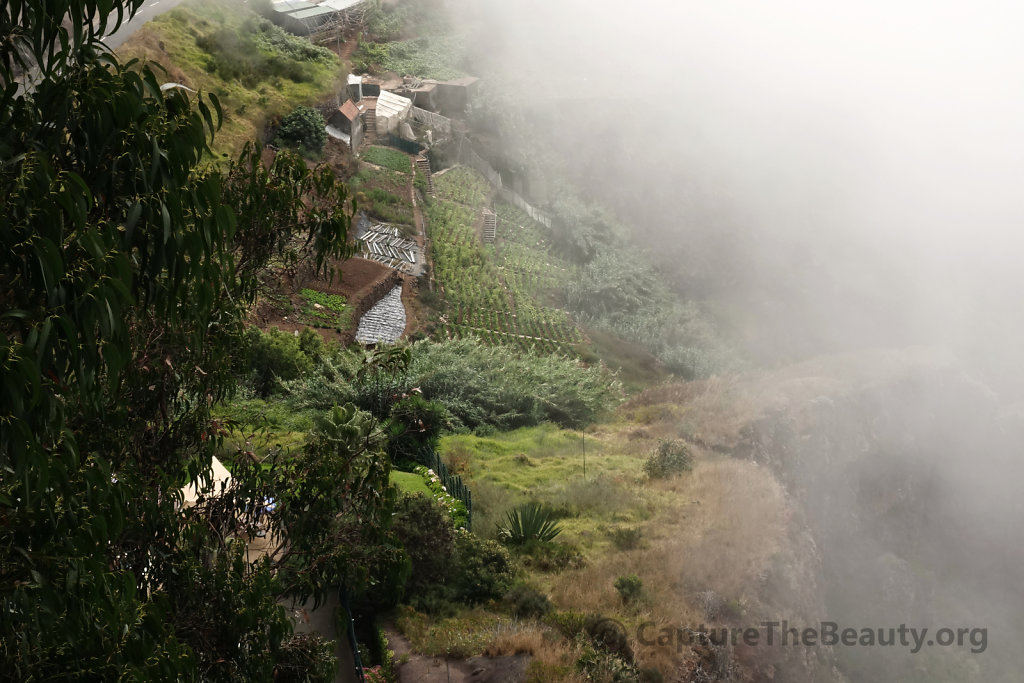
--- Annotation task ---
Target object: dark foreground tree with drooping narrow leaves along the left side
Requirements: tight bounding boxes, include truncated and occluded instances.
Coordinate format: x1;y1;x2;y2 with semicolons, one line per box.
0;0;395;681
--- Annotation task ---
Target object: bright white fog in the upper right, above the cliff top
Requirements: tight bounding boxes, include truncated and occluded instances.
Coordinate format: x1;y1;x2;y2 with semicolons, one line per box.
466;0;1024;394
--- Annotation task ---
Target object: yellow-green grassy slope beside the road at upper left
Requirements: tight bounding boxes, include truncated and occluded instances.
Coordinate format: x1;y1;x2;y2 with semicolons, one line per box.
117;0;341;157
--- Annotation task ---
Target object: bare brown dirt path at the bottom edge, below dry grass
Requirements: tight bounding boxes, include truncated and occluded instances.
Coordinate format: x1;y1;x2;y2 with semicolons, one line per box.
384;625;529;683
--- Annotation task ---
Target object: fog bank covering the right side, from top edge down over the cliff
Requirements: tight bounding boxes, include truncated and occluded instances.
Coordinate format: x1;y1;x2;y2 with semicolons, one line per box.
461;0;1024;681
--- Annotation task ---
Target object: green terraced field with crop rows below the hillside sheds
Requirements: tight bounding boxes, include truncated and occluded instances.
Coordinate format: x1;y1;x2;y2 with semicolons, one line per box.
427;168;584;355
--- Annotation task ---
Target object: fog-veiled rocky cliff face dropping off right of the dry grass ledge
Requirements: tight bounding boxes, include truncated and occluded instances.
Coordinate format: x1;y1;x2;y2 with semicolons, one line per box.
651;350;1024;682
